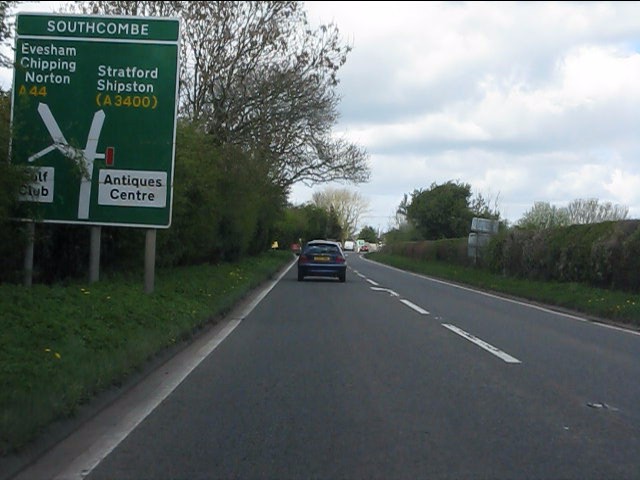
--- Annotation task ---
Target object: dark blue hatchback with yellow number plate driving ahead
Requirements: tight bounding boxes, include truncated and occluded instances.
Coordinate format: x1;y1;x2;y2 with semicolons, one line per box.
298;240;347;282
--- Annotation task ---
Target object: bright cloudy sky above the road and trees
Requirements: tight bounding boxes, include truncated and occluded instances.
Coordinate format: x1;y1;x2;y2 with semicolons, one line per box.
3;1;640;231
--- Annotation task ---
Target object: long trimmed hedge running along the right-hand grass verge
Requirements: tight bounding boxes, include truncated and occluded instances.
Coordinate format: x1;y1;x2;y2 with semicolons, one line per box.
385;220;640;292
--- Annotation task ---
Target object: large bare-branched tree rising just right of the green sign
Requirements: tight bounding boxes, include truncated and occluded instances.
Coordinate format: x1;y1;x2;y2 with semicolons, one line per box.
71;1;370;190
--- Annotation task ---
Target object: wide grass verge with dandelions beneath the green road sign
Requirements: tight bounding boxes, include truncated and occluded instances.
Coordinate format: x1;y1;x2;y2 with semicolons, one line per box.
0;251;291;455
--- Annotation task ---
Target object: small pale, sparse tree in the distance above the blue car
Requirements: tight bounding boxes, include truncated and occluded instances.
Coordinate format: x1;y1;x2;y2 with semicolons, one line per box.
311;187;369;241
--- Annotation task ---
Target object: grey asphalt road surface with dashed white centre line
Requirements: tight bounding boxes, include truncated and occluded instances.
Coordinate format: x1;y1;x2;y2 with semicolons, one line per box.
8;254;640;480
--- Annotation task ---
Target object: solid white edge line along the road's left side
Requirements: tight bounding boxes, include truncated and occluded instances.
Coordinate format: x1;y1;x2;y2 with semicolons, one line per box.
54;260;296;480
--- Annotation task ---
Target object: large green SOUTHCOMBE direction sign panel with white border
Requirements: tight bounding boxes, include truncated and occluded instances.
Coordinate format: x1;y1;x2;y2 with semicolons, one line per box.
11;13;180;228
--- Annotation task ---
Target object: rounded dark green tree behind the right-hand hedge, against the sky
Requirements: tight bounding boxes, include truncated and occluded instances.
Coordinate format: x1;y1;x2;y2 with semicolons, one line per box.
407;180;473;240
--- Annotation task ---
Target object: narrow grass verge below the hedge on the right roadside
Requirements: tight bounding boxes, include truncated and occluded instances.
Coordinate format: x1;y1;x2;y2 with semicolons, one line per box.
368;252;640;328
